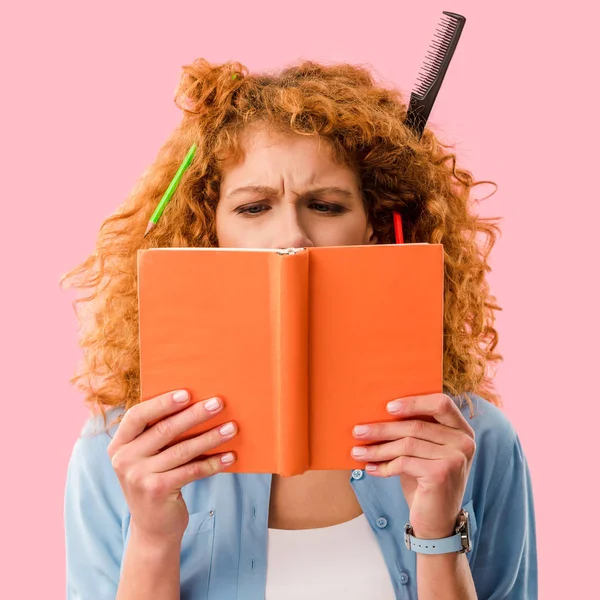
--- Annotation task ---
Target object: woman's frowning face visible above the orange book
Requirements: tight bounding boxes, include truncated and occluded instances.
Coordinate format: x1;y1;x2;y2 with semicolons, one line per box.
216;126;377;248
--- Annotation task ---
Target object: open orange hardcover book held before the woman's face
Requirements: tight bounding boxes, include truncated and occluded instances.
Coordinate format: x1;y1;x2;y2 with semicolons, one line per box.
138;244;444;476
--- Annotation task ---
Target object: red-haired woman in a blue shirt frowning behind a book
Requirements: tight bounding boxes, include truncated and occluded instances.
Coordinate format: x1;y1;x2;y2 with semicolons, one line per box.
65;60;537;600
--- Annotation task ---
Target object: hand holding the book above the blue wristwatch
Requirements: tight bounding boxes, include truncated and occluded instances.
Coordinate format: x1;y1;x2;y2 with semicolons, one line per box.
352;394;475;539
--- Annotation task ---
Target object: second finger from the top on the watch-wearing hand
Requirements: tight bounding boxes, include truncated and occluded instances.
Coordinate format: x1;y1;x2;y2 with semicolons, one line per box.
352;418;465;444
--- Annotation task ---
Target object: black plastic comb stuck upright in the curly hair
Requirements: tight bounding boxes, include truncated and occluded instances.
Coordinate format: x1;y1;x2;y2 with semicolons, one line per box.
406;11;466;140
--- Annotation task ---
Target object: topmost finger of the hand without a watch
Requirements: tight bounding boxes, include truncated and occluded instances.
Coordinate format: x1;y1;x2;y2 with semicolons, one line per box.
108;390;191;454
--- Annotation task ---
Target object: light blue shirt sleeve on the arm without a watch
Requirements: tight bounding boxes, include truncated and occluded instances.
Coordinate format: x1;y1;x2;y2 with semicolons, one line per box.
64;426;123;600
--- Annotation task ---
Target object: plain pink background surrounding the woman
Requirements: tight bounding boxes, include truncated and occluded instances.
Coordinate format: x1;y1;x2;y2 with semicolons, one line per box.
0;0;600;600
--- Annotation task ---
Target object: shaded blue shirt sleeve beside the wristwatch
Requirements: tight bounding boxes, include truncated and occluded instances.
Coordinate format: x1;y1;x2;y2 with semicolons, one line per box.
472;432;538;600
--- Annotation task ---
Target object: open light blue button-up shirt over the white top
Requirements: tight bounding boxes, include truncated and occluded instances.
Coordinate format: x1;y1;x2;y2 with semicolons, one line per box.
65;396;537;600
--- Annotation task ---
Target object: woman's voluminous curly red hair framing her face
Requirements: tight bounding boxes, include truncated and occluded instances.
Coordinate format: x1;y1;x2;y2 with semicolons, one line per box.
62;59;501;422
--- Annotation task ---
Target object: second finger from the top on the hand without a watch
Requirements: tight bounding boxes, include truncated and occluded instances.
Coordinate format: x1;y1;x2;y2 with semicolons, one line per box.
131;398;223;456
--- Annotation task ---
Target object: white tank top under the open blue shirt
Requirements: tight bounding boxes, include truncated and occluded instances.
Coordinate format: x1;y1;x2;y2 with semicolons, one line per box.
265;514;396;600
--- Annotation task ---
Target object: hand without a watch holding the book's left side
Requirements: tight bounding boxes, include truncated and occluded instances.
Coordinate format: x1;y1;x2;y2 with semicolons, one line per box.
108;390;237;544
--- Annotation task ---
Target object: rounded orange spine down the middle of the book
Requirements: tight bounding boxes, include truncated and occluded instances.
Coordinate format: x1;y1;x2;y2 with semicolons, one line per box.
270;250;310;477
